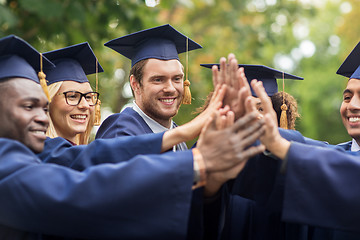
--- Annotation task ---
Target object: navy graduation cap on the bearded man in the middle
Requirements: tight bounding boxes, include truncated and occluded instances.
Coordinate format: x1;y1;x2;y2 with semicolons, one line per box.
104;24;202;66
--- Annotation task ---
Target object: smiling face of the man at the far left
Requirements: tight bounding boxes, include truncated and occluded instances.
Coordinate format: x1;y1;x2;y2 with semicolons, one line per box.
0;78;49;153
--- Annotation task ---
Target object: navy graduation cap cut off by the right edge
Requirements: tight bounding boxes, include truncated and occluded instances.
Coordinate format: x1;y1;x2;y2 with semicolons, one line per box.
336;42;360;79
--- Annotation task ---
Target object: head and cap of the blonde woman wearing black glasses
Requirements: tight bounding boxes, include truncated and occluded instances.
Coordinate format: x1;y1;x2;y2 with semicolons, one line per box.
44;42;103;145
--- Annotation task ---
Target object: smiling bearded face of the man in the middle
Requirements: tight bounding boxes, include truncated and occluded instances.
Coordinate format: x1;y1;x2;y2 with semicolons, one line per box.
130;59;184;127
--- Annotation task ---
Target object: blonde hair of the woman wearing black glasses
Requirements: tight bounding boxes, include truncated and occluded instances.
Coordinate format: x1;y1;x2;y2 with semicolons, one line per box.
46;81;95;145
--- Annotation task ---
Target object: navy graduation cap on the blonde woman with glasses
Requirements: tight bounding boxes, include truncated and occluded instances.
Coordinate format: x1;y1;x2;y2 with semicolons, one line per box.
44;42;104;85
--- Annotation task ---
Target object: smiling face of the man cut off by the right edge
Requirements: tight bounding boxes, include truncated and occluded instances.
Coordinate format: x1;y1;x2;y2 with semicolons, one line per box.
340;78;360;142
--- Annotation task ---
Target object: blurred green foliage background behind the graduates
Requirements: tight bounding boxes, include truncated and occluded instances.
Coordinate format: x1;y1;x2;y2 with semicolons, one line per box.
0;0;354;143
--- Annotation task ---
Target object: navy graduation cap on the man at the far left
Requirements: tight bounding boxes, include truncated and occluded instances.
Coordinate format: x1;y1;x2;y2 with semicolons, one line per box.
0;35;54;83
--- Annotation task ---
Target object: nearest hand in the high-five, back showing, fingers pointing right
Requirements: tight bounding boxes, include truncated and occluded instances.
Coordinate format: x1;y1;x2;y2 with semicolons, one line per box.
197;98;264;173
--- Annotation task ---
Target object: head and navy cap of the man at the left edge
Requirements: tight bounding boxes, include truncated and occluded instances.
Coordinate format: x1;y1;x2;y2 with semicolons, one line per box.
0;35;53;153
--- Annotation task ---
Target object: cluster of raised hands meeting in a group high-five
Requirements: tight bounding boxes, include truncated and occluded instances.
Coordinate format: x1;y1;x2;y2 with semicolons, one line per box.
198;54;290;196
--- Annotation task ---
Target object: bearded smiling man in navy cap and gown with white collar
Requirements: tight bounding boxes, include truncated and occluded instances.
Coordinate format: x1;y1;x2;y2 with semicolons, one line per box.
96;24;201;150
